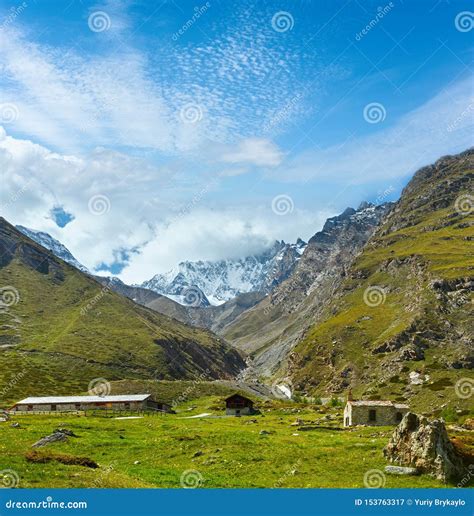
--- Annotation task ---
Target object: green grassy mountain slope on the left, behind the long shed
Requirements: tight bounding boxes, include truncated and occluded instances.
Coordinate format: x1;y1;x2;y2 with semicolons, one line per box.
0;218;243;400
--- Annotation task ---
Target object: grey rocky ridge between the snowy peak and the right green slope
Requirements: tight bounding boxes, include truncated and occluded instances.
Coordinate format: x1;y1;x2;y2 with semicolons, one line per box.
224;204;390;376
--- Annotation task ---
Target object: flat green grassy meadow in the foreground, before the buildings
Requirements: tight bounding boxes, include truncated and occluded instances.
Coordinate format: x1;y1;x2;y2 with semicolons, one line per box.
0;398;472;488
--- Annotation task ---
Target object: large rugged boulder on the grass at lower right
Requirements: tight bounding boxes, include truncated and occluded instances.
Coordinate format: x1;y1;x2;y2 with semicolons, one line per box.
384;412;465;482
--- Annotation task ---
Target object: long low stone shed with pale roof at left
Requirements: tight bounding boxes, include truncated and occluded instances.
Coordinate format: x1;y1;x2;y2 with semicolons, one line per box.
10;394;171;413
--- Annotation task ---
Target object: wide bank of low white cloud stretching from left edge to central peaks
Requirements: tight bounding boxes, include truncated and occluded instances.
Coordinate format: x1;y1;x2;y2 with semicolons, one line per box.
0;127;329;283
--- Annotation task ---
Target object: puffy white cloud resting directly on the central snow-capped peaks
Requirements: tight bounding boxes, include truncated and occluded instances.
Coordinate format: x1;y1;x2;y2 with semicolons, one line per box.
120;207;330;283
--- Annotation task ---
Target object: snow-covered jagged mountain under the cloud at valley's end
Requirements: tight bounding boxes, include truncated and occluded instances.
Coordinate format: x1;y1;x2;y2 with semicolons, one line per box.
140;239;306;305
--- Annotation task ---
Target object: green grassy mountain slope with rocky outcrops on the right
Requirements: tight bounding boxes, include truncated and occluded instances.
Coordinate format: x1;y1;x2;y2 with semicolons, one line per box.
290;150;474;408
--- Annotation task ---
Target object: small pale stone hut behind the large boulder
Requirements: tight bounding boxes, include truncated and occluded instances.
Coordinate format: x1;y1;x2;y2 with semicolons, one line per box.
344;400;409;426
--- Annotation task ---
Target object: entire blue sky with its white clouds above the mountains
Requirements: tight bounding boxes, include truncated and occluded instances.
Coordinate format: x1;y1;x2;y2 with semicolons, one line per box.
0;0;474;282
